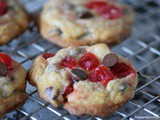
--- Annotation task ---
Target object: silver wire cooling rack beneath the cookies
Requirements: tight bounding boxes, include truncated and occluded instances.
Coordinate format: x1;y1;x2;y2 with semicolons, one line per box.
0;0;160;120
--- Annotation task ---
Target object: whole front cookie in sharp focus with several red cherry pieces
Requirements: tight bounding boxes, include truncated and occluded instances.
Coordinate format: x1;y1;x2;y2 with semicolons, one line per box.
28;44;138;116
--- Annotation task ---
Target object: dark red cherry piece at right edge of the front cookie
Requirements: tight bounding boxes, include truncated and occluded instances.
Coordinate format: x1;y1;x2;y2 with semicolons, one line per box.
111;63;135;78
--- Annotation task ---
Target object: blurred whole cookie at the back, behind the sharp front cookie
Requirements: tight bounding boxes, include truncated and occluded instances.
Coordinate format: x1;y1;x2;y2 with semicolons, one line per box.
39;0;135;47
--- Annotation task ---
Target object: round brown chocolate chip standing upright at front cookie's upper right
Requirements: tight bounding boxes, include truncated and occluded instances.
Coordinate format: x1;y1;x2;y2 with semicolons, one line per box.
103;53;118;67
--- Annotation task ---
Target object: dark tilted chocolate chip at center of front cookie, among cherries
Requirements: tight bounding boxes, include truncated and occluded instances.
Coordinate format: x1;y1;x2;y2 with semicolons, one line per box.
71;69;88;81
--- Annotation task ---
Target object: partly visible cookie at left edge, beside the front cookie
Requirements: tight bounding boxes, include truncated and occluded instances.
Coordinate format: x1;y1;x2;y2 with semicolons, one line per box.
0;53;27;118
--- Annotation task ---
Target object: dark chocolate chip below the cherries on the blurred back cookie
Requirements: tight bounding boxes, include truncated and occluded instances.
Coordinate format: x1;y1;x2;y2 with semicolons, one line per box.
78;11;93;19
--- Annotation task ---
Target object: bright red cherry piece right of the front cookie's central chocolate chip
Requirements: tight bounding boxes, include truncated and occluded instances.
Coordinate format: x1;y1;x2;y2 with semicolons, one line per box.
89;66;114;85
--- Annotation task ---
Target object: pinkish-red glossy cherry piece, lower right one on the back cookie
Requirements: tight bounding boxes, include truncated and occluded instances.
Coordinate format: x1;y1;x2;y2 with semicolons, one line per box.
99;6;122;19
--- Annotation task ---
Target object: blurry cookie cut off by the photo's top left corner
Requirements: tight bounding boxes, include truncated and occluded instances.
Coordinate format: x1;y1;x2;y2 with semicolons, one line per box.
0;0;29;45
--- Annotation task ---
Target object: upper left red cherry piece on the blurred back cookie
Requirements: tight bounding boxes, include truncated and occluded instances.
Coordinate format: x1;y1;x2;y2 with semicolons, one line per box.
85;1;107;11
